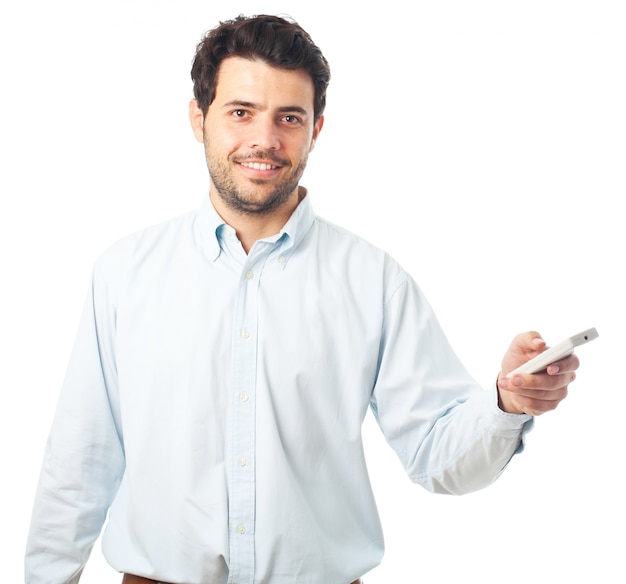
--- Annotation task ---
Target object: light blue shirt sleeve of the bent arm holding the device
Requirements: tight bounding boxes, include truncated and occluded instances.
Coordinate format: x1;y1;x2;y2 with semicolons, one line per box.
371;276;531;494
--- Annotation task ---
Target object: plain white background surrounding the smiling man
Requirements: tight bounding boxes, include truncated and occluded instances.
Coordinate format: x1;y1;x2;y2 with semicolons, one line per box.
0;0;626;584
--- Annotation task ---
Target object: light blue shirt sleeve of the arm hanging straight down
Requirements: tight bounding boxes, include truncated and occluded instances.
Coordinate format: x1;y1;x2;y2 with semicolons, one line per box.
25;262;124;584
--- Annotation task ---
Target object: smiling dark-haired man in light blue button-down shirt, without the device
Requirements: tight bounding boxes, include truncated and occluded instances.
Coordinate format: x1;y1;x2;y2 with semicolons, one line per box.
26;16;578;584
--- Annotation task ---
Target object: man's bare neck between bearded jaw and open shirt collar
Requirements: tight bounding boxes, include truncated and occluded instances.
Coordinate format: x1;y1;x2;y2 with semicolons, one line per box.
209;187;306;253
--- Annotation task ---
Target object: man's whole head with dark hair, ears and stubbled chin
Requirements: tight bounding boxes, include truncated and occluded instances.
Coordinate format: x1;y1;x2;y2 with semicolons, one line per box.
189;16;330;222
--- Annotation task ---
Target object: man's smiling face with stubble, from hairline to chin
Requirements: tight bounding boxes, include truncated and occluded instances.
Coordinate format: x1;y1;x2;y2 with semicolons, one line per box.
192;57;323;215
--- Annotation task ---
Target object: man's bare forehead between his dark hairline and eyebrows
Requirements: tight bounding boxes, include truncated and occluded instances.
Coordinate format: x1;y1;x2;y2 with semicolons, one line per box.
214;57;315;111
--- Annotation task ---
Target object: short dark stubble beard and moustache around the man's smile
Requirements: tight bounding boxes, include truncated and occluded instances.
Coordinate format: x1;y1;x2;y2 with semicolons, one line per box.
204;136;307;215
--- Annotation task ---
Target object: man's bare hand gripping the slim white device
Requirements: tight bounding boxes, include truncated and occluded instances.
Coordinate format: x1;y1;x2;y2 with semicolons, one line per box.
498;331;579;416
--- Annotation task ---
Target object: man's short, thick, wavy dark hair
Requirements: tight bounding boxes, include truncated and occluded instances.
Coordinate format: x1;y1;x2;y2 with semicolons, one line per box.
191;15;330;121
